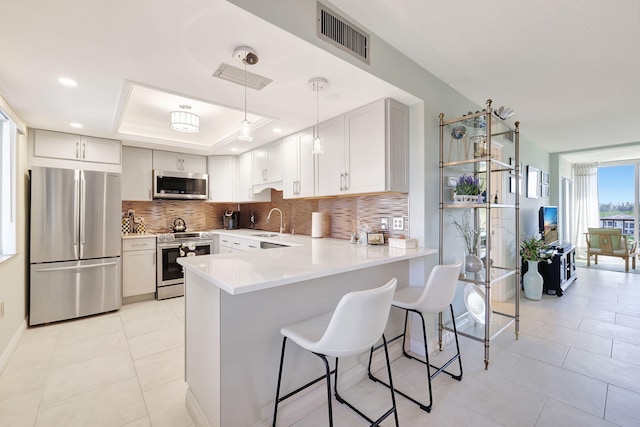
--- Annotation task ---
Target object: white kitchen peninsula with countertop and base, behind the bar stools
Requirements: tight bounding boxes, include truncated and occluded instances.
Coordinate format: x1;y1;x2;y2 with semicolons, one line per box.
178;234;437;427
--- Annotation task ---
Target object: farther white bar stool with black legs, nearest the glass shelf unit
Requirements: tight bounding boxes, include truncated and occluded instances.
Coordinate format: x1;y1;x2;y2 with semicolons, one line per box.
369;261;462;412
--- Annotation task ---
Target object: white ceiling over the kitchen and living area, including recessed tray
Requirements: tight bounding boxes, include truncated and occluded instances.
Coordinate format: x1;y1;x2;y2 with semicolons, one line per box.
0;0;640;162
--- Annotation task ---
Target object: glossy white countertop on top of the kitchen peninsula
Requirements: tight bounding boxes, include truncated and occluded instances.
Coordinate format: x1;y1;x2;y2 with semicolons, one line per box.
178;229;438;295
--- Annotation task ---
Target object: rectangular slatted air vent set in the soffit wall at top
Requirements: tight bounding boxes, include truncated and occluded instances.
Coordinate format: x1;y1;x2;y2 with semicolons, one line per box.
316;2;369;64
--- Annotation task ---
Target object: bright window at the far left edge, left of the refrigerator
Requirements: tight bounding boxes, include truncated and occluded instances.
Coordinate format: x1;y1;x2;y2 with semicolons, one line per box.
0;115;17;262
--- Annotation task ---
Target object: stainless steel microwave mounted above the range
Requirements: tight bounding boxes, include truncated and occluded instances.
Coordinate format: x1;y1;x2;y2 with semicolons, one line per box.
153;170;209;200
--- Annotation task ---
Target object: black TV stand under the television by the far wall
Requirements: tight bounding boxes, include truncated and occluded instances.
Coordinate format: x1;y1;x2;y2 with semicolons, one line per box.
538;244;577;297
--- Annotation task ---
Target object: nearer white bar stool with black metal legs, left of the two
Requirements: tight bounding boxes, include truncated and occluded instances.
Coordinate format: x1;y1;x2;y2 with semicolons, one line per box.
273;278;398;427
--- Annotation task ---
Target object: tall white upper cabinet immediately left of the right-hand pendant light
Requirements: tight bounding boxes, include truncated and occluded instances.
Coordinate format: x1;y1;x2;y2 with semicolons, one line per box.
282;128;315;199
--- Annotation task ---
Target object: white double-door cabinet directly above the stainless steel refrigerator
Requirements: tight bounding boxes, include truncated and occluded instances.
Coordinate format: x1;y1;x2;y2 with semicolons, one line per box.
30;129;120;171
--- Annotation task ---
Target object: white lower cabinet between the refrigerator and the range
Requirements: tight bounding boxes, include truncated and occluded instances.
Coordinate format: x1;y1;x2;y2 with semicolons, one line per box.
122;237;156;297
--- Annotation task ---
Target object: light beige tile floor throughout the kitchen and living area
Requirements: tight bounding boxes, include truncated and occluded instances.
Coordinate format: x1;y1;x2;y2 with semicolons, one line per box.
0;268;640;427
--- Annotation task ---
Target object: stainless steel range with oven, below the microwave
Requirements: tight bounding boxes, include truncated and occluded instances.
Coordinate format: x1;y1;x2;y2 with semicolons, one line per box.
156;231;213;299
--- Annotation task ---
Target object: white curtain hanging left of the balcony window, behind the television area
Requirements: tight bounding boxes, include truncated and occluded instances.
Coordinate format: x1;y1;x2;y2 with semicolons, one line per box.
572;163;600;257
